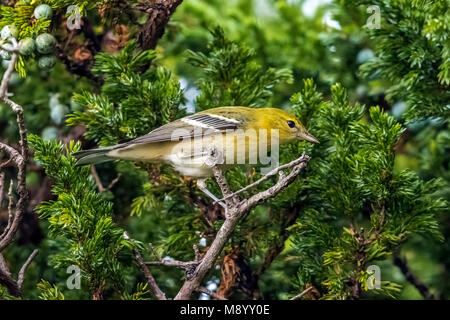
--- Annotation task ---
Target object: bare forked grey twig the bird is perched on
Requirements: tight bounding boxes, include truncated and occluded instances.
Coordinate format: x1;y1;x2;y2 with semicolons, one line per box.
175;155;310;300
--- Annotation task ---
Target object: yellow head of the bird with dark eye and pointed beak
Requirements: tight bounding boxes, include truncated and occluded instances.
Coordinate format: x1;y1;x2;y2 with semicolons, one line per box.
256;108;319;143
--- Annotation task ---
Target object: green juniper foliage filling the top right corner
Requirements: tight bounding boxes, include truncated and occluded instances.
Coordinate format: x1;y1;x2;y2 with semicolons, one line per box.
342;0;450;119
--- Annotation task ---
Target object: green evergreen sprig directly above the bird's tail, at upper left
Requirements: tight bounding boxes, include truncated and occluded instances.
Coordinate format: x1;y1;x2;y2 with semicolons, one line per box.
67;41;184;146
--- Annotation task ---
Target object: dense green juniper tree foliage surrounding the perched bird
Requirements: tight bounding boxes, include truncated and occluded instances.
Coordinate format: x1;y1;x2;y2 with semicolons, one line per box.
0;1;449;299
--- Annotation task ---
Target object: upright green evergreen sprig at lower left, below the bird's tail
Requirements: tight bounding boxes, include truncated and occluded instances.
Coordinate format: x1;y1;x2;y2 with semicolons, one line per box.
29;135;132;297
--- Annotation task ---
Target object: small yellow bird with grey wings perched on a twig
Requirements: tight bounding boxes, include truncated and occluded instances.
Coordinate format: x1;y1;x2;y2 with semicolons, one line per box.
73;107;319;208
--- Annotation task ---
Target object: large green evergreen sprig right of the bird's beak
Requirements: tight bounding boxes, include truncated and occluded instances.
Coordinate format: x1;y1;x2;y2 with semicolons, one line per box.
292;80;447;299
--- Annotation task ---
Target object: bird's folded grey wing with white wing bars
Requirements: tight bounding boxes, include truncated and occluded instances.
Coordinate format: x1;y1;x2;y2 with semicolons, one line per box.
124;113;240;146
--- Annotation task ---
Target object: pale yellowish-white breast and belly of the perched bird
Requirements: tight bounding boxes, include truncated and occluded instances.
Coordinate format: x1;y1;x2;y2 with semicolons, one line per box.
108;128;275;177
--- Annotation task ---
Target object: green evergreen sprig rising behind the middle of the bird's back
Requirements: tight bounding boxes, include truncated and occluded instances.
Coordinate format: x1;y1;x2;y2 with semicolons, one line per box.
187;28;293;111
